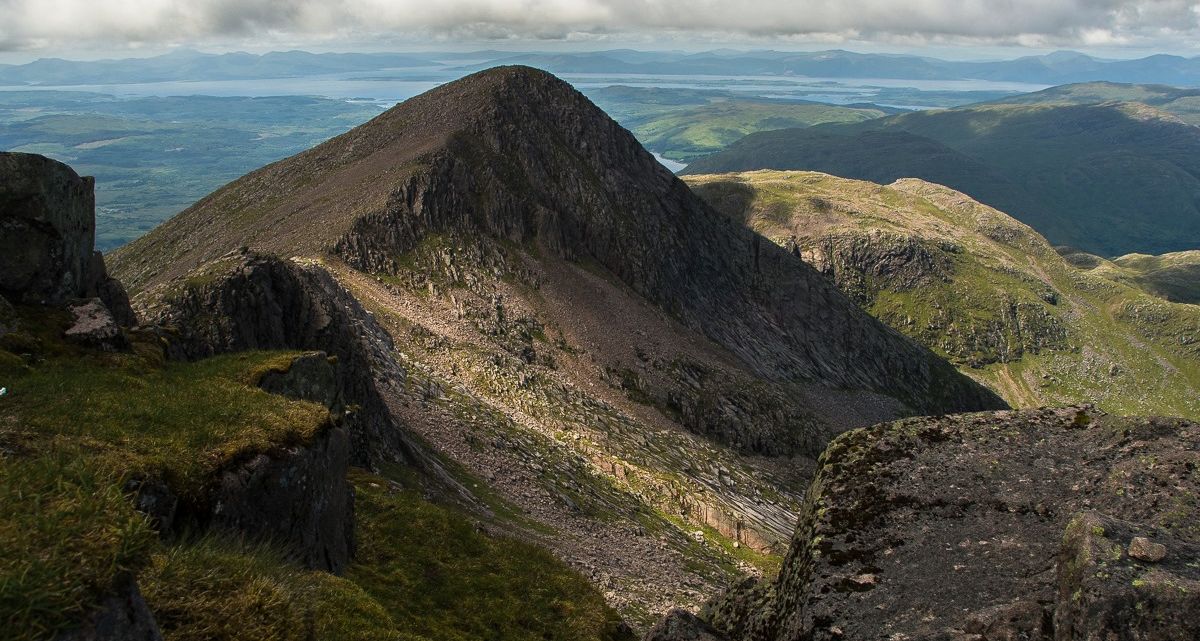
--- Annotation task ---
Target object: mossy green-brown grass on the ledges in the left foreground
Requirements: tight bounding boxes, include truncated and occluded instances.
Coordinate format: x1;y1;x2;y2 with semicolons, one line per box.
0;308;628;641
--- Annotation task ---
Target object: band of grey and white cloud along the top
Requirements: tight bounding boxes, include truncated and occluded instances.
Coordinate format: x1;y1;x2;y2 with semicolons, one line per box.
0;0;1200;49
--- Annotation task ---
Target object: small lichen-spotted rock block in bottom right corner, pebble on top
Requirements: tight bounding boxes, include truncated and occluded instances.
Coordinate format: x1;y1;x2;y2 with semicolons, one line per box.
1055;511;1200;641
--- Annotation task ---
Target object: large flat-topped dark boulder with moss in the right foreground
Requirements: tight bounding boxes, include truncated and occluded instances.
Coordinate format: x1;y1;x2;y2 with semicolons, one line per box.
708;408;1200;641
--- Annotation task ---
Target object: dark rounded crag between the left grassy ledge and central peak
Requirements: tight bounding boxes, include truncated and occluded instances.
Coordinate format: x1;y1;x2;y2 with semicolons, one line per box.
146;253;413;466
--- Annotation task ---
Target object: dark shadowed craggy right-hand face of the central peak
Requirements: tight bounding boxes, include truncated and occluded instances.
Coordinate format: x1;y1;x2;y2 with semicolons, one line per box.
335;67;1004;422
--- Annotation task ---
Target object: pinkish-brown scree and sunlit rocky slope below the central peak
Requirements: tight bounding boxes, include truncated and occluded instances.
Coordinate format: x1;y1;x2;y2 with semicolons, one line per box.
326;252;814;628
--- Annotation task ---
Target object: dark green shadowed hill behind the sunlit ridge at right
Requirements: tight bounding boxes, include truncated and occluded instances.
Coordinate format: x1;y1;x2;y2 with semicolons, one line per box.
686;103;1200;256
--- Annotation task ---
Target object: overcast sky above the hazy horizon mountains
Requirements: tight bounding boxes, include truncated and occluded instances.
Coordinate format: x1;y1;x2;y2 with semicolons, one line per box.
0;0;1200;61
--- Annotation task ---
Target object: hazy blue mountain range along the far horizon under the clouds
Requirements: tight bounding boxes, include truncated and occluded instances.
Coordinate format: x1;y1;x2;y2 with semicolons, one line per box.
7;49;1200;86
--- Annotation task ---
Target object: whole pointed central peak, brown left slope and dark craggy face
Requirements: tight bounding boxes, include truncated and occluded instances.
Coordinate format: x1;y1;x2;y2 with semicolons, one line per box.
114;67;1000;432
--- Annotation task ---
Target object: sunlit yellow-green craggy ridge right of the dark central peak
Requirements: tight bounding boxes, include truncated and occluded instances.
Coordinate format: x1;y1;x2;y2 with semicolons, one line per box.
689;172;1200;418
